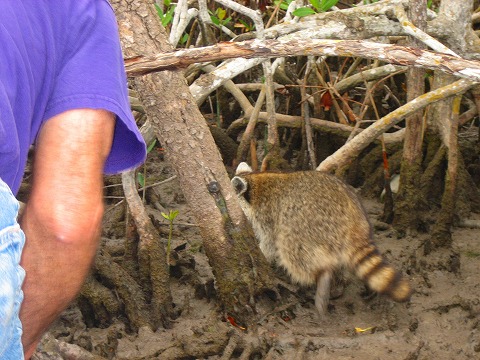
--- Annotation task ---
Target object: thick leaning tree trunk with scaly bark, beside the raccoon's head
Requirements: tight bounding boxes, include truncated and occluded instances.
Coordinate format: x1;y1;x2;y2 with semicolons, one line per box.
111;0;274;324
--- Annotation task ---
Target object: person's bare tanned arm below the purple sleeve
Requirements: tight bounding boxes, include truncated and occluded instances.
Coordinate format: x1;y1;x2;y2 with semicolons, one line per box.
20;109;115;359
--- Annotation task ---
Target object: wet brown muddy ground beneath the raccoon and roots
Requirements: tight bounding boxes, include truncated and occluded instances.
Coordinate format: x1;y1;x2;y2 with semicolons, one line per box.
34;155;480;360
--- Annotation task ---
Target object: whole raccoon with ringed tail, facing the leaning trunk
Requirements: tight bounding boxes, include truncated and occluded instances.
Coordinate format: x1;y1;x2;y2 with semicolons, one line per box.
231;163;412;314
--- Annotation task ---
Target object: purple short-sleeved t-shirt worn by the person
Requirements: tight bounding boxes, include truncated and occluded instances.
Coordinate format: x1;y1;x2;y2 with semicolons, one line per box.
0;0;146;193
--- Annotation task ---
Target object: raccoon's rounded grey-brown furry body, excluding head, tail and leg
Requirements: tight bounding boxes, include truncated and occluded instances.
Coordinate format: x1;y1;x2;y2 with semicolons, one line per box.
246;171;371;284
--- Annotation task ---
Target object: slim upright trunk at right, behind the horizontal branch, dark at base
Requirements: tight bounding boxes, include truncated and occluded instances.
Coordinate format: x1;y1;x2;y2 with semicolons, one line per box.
394;0;427;233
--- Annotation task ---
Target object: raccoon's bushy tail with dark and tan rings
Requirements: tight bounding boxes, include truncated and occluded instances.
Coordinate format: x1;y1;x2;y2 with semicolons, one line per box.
352;243;412;302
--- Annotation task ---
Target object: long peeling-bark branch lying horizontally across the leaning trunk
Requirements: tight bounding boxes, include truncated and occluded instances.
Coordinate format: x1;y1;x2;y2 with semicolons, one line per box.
125;39;480;81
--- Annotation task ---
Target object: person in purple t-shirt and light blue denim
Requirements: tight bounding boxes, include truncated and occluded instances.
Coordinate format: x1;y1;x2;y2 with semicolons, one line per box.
0;0;146;360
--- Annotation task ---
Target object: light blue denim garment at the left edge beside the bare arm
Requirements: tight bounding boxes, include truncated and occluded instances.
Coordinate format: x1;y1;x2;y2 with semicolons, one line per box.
0;179;25;360
